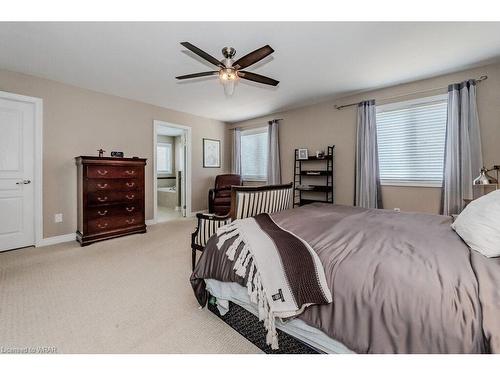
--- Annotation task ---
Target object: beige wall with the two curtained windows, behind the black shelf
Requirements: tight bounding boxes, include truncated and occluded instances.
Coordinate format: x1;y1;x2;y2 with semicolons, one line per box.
231;64;500;213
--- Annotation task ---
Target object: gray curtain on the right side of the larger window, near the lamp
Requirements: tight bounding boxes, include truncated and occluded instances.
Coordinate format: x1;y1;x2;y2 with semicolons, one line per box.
441;79;483;215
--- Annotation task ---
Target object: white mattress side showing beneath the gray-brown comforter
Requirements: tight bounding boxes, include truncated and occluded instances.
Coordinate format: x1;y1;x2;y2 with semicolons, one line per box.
205;279;354;354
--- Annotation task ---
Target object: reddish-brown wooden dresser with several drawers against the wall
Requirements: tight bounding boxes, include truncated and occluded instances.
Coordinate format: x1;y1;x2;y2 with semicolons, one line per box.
75;156;146;246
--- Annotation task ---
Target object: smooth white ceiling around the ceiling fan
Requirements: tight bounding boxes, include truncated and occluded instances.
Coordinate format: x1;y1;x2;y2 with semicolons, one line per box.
0;22;500;122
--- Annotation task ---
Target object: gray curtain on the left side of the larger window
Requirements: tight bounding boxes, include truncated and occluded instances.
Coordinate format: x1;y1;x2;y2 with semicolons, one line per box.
354;100;382;208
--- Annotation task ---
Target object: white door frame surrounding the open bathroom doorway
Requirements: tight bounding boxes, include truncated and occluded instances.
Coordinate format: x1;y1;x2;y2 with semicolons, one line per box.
152;120;192;224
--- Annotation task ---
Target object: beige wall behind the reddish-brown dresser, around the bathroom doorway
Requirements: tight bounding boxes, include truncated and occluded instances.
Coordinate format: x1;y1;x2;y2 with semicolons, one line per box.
0;70;229;237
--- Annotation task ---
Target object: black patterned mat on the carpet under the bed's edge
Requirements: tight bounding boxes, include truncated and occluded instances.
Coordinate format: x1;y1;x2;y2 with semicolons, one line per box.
208;297;318;354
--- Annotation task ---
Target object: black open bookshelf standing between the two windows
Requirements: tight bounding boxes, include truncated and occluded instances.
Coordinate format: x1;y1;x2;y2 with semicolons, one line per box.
293;145;335;207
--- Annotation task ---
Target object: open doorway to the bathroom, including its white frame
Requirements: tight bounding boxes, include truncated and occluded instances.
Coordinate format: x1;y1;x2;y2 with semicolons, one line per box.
153;120;191;223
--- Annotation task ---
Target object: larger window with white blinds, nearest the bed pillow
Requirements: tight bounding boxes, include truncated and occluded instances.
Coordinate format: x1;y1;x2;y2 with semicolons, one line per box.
377;95;447;186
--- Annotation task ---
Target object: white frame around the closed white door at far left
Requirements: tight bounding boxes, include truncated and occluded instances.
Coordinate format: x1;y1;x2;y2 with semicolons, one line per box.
0;91;43;247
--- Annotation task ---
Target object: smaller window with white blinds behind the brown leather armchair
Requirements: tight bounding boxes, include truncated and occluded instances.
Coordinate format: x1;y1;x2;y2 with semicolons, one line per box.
241;128;268;181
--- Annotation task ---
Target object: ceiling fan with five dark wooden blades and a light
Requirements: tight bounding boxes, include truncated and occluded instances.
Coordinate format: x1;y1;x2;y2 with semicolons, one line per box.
175;42;279;95
